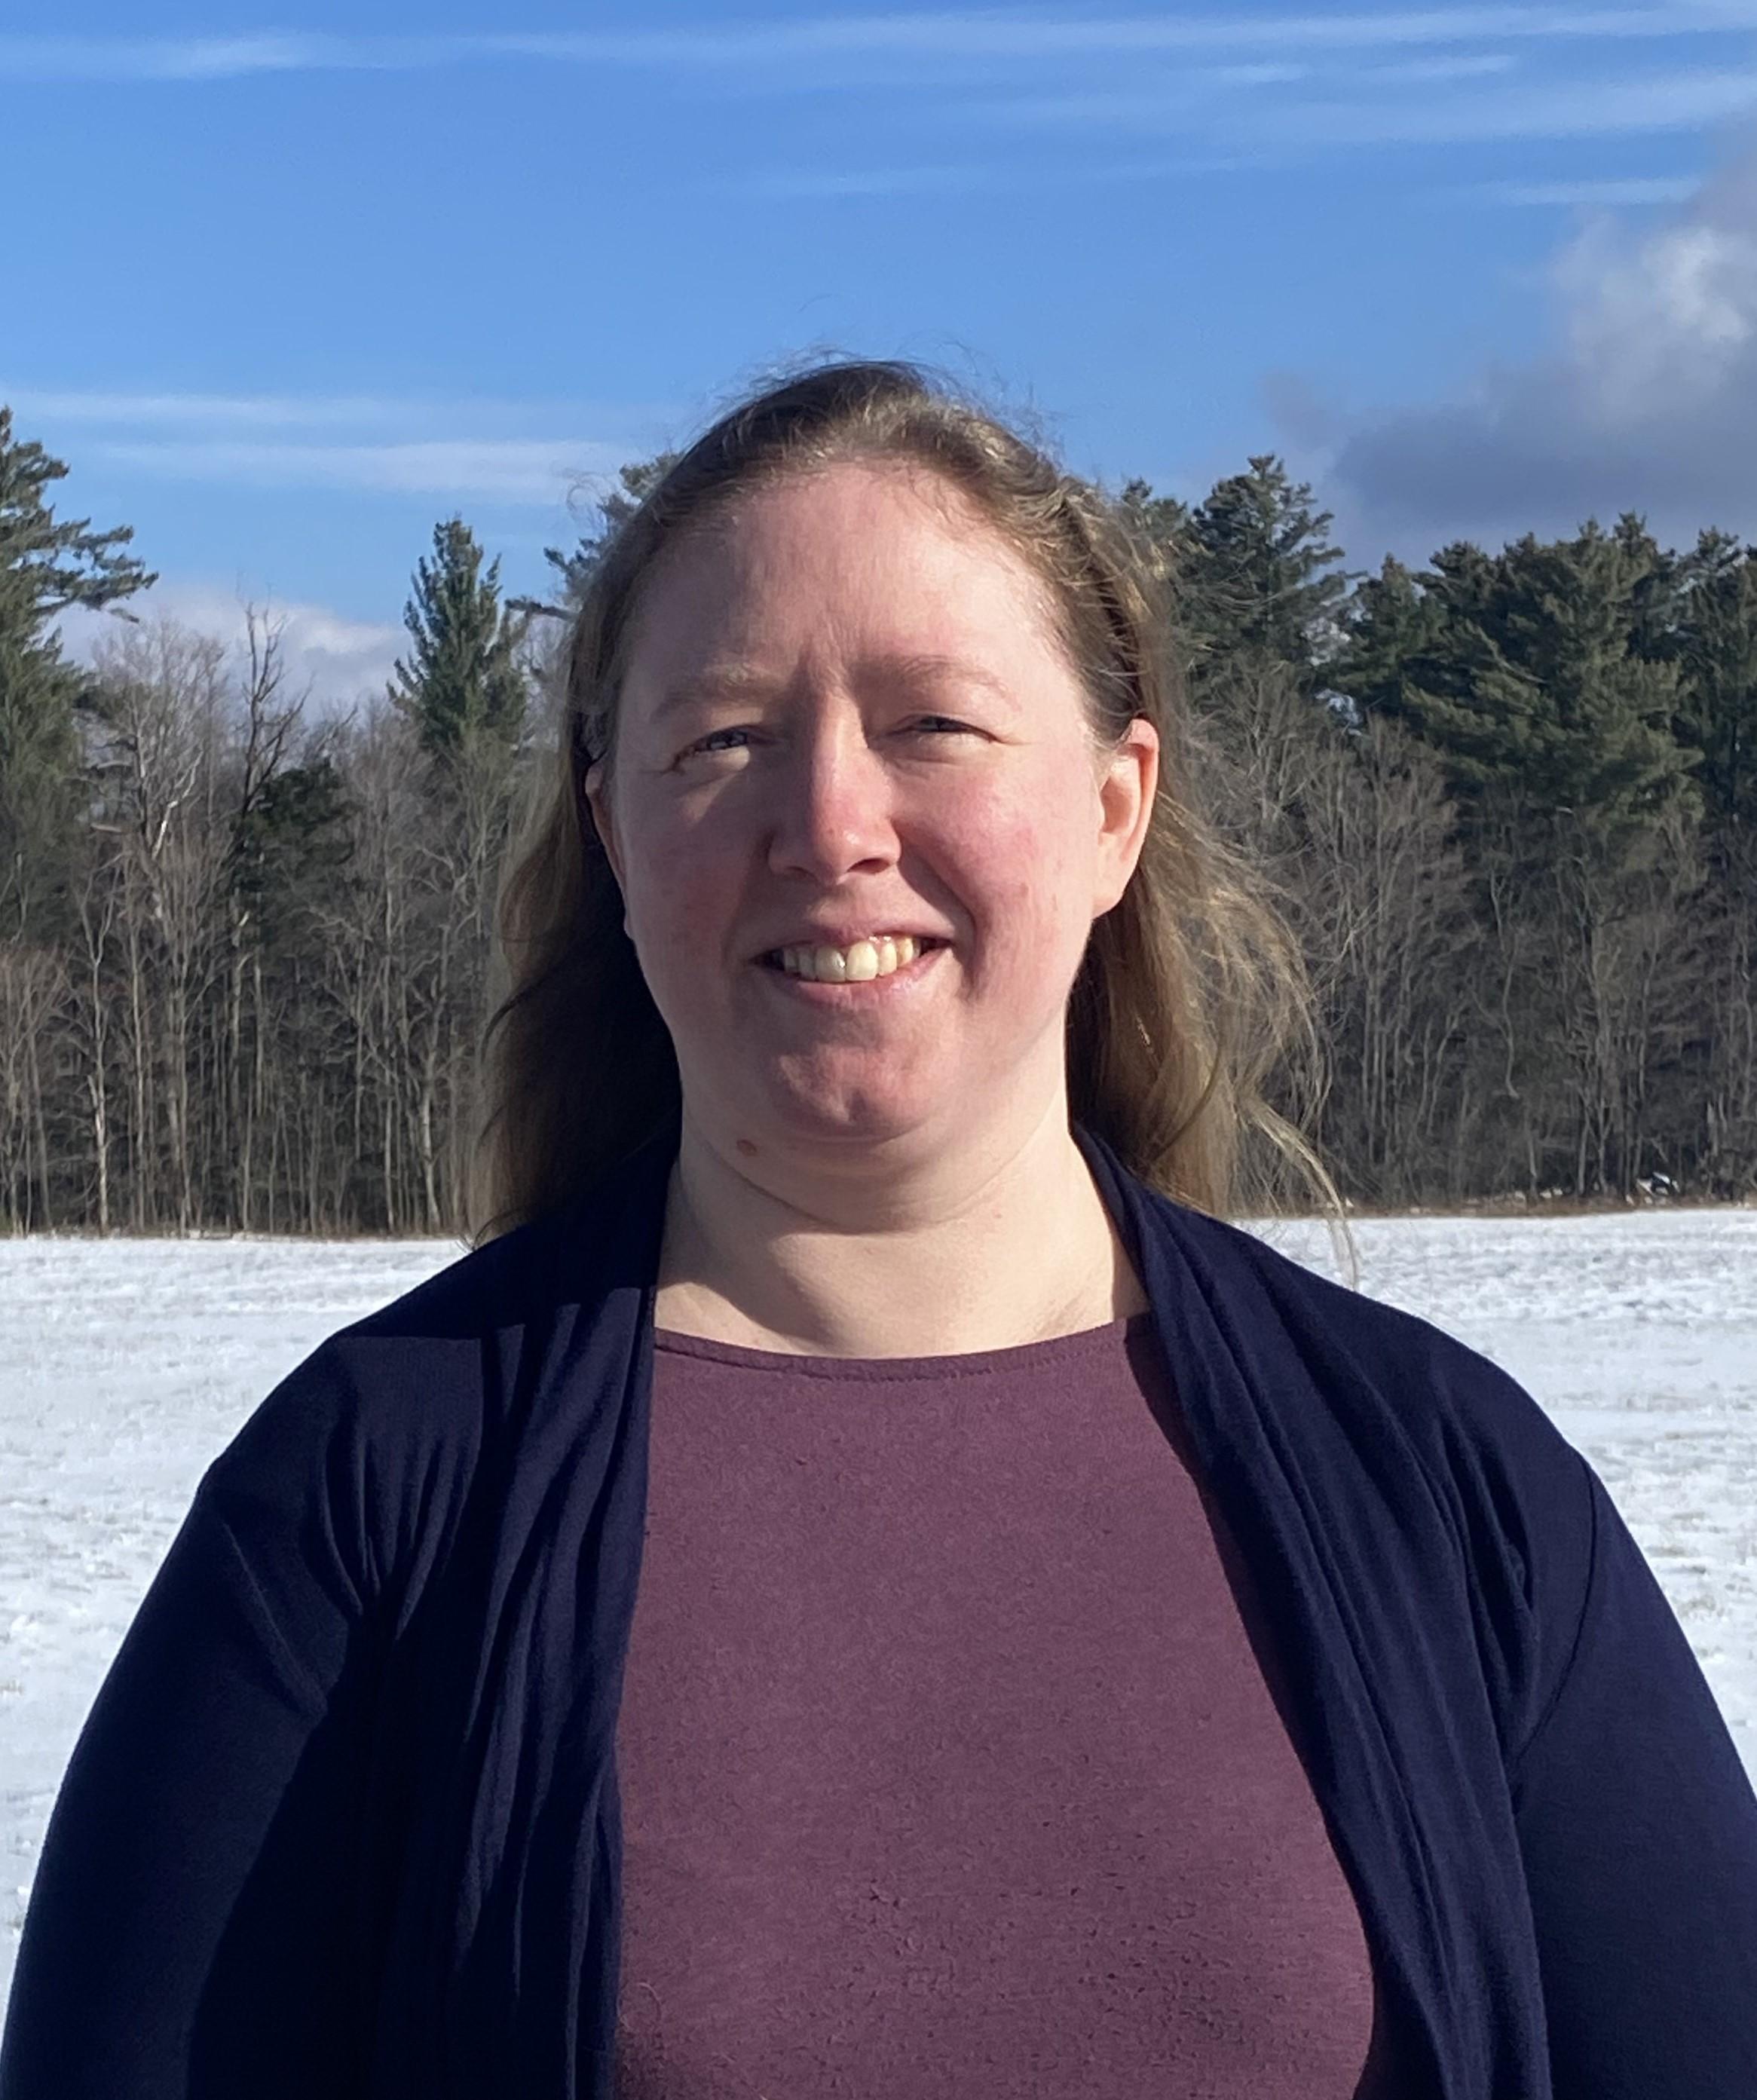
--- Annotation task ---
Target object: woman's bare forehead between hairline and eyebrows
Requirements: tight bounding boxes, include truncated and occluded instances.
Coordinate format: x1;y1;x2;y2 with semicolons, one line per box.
626;462;1060;684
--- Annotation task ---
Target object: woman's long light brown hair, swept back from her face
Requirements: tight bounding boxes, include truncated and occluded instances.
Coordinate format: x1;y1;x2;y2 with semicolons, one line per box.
466;359;1339;1243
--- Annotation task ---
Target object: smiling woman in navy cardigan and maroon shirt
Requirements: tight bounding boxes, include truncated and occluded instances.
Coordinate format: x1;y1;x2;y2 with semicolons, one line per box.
0;363;1757;2100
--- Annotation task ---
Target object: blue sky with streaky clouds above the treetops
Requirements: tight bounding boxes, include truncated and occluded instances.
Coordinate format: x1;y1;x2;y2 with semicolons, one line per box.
0;0;1757;693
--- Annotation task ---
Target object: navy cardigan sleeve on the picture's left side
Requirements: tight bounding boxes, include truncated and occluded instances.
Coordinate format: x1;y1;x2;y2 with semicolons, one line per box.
0;1352;386;2100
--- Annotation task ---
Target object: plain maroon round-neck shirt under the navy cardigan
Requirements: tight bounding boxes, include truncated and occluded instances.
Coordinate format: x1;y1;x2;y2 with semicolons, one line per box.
617;1312;1373;2100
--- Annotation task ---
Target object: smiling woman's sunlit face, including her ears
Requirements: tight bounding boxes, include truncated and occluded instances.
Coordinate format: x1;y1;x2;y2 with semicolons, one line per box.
588;464;1157;1153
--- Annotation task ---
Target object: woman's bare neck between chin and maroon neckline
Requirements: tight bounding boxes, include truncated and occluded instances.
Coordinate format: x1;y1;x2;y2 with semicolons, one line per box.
657;1094;1146;1357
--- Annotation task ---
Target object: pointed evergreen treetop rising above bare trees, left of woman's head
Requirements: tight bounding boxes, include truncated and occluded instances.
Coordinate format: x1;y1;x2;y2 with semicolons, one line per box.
390;516;525;762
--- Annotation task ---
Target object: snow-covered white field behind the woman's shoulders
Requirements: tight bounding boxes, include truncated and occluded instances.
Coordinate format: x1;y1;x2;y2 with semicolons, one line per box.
0;1210;1757;2004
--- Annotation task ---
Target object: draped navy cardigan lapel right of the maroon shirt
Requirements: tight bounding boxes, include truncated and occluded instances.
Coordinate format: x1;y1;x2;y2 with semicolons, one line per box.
1075;1130;1549;2100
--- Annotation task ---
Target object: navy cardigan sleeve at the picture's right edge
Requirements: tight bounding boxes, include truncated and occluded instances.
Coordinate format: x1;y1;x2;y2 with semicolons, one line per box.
1509;1459;1757;2100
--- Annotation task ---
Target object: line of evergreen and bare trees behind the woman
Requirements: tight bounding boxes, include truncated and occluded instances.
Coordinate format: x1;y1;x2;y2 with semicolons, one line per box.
0;407;1757;1232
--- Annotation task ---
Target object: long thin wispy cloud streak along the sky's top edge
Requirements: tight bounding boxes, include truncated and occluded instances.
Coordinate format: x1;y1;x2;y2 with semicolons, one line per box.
0;0;1757;86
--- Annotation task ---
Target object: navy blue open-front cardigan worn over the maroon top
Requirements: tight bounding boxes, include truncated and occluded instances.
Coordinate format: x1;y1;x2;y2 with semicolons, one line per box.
0;1130;1757;2100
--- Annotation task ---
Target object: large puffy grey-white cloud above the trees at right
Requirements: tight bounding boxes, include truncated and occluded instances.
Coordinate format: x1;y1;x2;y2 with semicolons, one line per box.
1318;153;1757;556
